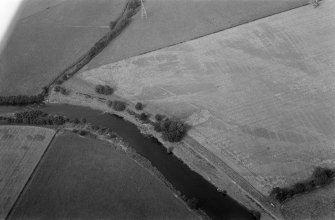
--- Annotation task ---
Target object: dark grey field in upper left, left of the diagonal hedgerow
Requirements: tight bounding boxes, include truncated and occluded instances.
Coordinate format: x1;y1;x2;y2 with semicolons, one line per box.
0;0;124;96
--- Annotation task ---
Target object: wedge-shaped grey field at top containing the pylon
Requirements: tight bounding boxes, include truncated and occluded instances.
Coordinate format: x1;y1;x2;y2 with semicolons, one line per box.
82;0;309;69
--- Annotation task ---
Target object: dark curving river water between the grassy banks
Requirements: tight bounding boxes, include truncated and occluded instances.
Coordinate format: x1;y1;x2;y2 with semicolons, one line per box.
0;104;253;220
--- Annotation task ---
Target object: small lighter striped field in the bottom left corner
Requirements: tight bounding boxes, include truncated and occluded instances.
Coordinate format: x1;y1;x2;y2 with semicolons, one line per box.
0;126;55;219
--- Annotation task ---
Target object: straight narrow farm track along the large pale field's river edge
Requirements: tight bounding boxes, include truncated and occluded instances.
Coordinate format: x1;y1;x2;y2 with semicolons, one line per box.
184;136;281;219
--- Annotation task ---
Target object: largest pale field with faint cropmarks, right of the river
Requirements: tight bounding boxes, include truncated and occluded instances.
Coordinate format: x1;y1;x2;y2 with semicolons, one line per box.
66;1;335;218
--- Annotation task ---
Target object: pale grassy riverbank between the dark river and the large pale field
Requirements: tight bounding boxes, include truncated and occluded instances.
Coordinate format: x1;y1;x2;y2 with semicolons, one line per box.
47;87;273;219
